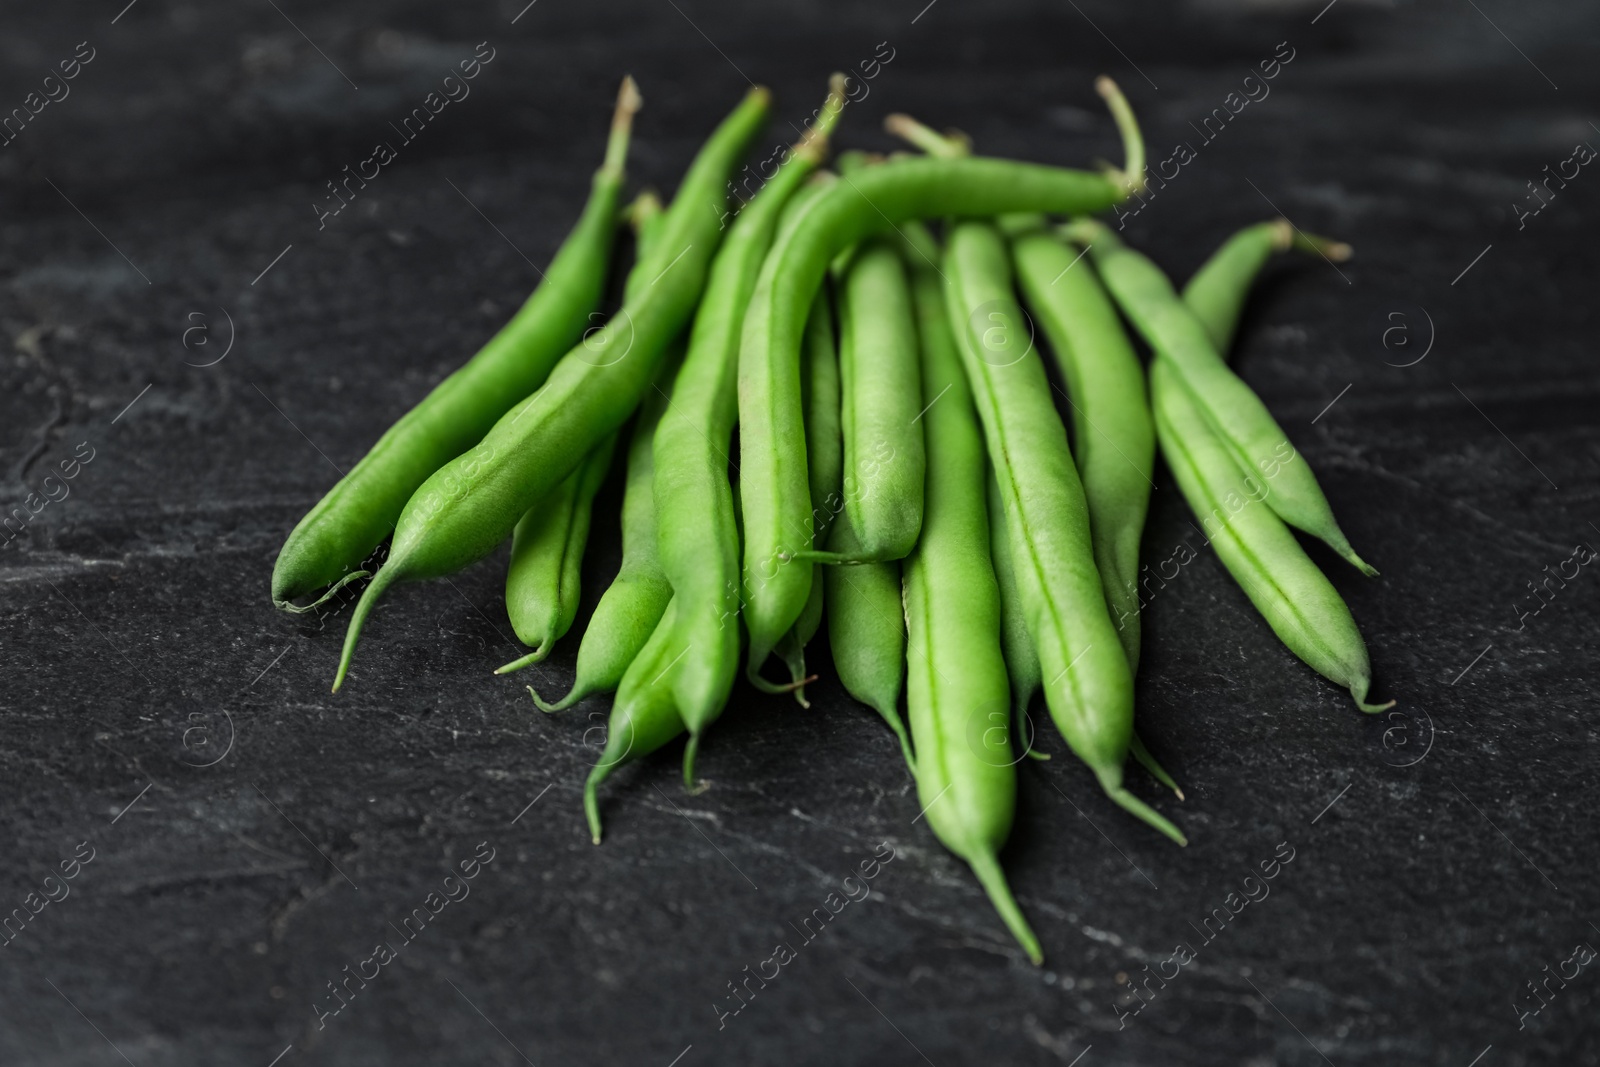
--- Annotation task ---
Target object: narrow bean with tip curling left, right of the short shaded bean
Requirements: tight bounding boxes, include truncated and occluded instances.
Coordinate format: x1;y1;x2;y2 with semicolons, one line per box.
521;343;678;700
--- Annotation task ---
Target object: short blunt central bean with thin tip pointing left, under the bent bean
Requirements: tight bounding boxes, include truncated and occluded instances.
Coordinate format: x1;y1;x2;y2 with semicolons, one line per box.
795;238;925;563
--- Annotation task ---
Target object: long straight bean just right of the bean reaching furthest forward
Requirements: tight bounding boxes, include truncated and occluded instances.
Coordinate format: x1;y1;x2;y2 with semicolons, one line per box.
944;222;1184;843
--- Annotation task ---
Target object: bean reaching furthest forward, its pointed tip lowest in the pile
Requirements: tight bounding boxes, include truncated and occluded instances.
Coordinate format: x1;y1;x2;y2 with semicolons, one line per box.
908;238;1045;965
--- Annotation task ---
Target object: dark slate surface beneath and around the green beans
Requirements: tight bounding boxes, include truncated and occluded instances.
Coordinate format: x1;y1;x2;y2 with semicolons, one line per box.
0;0;1600;1067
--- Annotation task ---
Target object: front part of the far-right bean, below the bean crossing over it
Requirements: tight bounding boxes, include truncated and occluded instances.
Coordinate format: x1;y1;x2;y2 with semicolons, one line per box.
1150;357;1392;712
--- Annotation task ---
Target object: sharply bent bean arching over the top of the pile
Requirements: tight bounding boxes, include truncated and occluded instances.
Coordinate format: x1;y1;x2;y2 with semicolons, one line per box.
739;78;1144;673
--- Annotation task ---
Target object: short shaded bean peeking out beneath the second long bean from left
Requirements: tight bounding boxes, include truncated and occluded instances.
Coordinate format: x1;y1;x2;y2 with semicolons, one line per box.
498;434;616;673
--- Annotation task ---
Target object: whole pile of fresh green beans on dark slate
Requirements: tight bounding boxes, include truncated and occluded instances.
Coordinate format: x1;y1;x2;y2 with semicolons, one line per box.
272;75;1392;965
